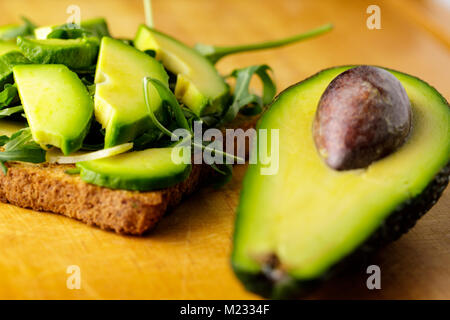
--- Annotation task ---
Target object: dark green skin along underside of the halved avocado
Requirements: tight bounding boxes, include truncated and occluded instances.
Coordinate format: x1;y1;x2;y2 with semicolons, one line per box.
232;162;450;299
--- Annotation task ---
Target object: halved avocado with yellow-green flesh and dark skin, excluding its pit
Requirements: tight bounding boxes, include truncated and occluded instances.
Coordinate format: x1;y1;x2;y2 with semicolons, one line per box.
232;66;450;299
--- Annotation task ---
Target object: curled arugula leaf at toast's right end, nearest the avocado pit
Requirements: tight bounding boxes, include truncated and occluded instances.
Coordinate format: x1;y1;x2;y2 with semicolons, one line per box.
220;65;277;125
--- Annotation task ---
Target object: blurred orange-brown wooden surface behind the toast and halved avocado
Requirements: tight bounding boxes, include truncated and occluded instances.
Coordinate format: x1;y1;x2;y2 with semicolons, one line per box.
0;0;450;99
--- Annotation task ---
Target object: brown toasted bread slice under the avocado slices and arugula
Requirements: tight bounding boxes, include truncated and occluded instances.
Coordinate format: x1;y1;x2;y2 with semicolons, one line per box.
0;117;257;235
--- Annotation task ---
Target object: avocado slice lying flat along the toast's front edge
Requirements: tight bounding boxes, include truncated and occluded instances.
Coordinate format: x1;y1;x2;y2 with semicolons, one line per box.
77;147;191;191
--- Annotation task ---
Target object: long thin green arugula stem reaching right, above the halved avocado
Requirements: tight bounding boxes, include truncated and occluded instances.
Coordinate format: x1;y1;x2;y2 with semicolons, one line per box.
194;24;333;64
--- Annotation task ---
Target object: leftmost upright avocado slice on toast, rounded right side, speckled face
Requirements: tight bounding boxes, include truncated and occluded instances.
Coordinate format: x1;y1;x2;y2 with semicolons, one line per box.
13;64;94;155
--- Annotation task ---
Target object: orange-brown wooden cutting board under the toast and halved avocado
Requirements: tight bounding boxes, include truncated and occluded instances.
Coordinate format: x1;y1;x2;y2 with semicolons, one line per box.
0;0;450;299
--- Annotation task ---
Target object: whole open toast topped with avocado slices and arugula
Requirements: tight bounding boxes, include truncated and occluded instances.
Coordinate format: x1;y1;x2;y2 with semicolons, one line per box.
0;10;331;235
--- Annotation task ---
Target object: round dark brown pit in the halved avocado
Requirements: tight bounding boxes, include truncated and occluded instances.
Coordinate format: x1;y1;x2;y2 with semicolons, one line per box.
313;66;411;170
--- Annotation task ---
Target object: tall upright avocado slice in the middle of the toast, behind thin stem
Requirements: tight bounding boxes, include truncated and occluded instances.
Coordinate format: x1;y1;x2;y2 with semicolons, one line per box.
95;37;169;148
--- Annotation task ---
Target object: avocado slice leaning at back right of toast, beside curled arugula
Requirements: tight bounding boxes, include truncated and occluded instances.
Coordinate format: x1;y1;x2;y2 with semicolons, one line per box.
134;25;228;115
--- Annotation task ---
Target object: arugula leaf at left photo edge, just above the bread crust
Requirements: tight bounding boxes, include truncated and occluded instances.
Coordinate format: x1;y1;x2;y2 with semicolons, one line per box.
0;128;45;174
